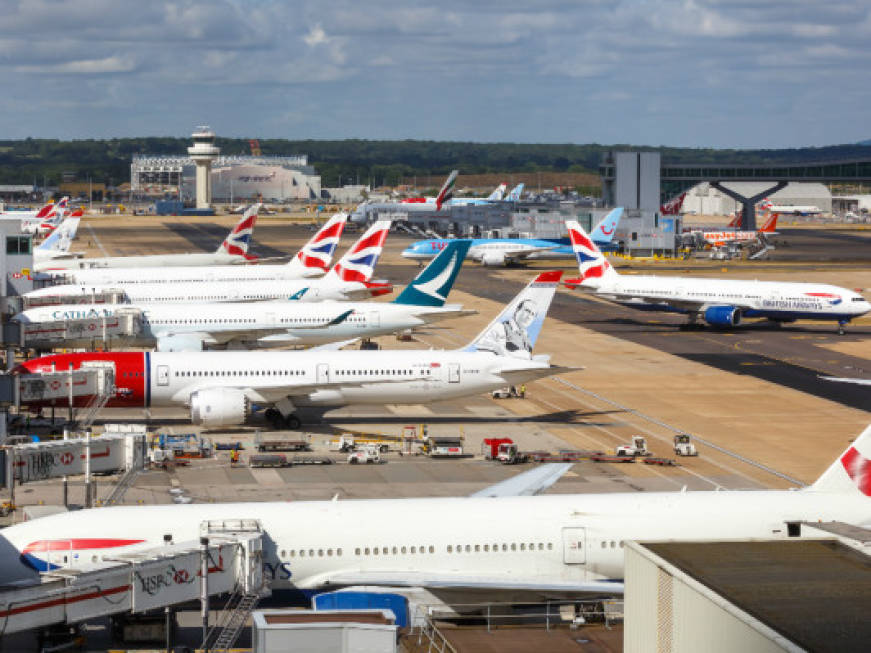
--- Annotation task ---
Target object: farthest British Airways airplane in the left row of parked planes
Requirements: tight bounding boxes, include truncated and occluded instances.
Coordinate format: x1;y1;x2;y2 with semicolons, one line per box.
34;204;260;279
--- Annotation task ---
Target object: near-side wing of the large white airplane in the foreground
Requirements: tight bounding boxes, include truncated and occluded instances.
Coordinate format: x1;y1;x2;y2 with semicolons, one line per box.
317;570;623;594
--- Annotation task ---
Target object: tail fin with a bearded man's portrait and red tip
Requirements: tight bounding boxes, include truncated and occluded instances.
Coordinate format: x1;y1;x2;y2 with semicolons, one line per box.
464;270;562;358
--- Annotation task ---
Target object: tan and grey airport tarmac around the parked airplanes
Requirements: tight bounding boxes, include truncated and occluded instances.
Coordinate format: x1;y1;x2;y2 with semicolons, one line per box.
3;211;871;650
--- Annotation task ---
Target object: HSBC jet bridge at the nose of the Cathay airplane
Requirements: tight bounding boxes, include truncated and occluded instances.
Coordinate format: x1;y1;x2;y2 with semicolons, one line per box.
22;307;144;349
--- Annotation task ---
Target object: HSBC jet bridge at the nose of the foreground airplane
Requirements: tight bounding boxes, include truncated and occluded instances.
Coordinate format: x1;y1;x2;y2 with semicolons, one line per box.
0;520;263;636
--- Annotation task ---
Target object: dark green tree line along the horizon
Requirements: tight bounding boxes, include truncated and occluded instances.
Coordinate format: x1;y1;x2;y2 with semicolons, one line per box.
0;137;871;187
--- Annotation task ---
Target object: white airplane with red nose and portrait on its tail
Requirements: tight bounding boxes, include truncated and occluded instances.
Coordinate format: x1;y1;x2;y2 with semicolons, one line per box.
18;271;569;428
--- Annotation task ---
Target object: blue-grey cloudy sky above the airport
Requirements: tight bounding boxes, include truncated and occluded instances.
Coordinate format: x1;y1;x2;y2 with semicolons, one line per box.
0;0;871;148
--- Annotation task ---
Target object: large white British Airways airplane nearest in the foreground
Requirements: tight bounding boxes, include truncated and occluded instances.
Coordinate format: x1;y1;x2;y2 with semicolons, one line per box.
0;427;871;596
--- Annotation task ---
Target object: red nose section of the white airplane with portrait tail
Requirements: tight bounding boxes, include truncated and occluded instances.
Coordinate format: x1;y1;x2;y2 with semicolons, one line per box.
16;351;148;408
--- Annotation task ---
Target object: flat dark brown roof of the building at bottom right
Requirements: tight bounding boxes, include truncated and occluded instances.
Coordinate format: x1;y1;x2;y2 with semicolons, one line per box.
641;539;871;651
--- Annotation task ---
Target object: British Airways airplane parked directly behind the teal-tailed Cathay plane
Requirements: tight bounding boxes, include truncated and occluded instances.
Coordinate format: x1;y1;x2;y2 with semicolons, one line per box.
25;217;392;304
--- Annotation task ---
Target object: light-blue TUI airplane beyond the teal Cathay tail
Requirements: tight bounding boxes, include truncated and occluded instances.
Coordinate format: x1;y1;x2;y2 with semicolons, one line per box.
402;208;623;266
